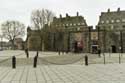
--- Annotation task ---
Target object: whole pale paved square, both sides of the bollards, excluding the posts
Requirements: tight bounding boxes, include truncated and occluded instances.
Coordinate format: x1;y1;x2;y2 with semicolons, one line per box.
0;51;125;83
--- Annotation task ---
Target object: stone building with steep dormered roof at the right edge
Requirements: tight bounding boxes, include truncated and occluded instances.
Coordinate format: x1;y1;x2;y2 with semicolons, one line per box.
96;8;125;53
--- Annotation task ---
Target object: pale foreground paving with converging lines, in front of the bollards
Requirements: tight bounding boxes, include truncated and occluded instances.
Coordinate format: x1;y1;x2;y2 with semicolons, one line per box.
0;64;125;83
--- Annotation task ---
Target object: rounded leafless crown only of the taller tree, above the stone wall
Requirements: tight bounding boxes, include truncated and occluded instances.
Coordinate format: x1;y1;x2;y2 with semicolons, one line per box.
31;9;54;30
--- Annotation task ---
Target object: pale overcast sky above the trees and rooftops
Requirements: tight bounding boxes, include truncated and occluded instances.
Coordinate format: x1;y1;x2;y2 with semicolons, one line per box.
0;0;125;40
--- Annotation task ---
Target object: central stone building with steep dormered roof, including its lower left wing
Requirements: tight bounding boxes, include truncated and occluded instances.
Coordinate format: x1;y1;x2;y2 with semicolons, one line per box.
27;12;92;52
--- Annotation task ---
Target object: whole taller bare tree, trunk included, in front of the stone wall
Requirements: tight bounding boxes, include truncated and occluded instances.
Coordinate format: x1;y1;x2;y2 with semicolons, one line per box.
31;9;54;50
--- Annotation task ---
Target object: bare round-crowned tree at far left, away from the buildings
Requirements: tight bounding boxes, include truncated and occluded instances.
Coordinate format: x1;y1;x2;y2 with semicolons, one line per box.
1;21;25;49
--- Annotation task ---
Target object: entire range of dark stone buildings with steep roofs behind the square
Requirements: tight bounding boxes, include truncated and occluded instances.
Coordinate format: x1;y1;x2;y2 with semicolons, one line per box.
27;8;125;53
